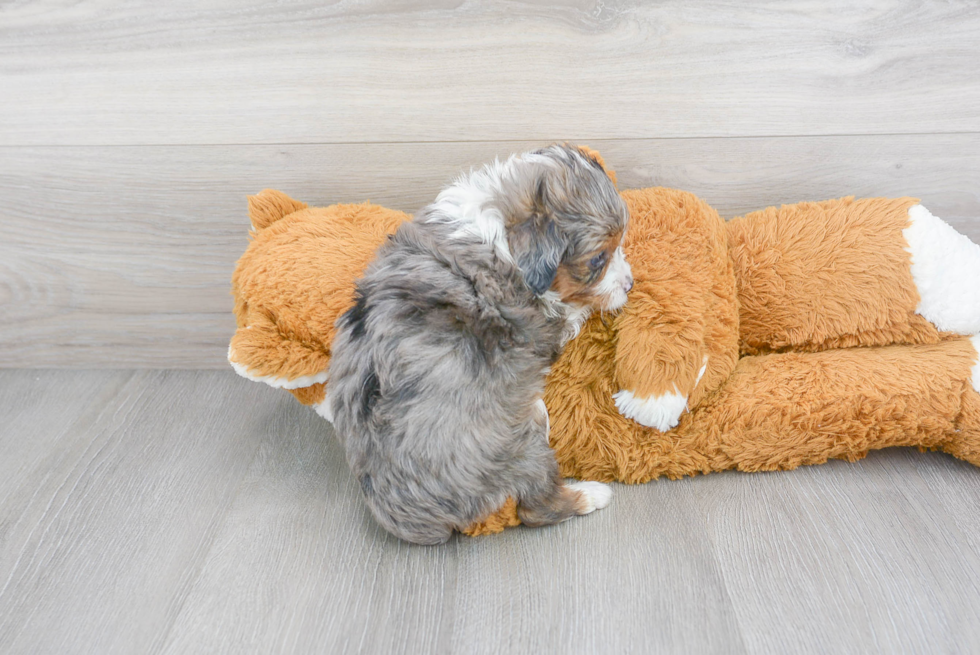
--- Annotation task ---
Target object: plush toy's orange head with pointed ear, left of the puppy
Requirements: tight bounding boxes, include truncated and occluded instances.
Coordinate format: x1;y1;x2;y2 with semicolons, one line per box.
228;197;411;405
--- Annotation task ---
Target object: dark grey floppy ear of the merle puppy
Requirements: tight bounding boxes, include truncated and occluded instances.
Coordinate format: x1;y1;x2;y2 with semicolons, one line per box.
507;189;568;296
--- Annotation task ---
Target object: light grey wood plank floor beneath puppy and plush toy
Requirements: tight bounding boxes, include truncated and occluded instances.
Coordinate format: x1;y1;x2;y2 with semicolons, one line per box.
0;370;980;655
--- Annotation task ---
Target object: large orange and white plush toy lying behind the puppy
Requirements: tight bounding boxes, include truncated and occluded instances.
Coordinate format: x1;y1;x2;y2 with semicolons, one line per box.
228;151;980;534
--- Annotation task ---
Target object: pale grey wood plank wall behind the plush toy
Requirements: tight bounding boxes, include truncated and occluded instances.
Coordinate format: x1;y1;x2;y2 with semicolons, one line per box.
0;0;980;368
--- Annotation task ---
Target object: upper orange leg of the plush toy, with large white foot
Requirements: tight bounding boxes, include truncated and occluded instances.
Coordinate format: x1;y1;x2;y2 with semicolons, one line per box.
727;198;980;354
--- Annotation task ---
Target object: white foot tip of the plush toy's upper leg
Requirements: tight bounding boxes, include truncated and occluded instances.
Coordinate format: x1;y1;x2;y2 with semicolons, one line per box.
902;205;980;334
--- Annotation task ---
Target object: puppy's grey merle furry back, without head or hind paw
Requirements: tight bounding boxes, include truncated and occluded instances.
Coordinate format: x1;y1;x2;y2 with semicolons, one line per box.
329;222;562;544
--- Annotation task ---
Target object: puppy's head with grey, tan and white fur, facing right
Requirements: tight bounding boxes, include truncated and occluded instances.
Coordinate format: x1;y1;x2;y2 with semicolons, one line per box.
499;145;633;310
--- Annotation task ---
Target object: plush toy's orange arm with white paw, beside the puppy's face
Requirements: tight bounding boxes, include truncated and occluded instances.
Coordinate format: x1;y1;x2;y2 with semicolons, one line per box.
613;189;738;431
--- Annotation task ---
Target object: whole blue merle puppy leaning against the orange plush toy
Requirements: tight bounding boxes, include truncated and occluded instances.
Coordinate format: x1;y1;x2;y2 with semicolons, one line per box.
324;145;633;544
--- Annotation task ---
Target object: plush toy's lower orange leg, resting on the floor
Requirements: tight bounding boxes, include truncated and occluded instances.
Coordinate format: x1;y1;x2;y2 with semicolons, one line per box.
692;336;980;471
